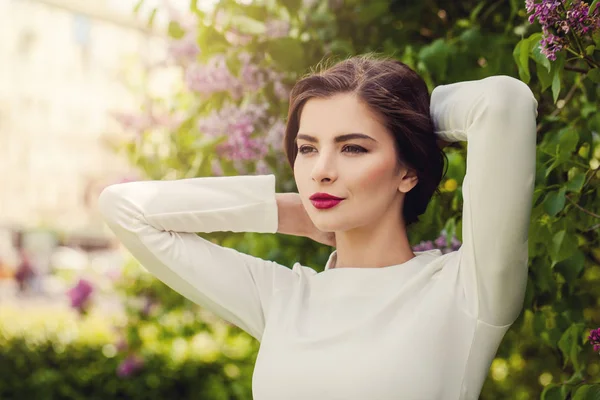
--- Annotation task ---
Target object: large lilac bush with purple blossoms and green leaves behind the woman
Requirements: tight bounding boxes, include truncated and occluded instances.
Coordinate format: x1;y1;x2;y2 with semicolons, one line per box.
90;0;600;399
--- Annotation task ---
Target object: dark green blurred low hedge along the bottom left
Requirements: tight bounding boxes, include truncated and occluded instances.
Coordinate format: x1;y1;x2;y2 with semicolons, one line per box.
0;338;252;400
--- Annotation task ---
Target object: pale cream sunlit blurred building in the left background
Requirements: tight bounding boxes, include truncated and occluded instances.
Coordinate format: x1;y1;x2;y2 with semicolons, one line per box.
0;0;190;247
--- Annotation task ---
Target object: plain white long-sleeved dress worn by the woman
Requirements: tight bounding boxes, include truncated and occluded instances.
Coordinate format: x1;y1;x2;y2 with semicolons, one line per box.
100;76;537;400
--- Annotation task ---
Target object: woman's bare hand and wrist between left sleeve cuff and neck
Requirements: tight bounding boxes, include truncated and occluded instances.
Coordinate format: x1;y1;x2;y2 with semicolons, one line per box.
275;193;335;246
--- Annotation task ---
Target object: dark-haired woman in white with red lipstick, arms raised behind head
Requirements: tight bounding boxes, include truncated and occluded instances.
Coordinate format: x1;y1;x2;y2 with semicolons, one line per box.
100;56;537;400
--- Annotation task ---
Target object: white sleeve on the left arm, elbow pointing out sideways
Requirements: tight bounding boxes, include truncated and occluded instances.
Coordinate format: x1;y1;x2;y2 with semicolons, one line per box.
99;175;293;340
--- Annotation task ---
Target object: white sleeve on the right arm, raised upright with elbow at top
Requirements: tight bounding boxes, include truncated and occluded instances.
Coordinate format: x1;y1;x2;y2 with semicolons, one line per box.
431;76;537;326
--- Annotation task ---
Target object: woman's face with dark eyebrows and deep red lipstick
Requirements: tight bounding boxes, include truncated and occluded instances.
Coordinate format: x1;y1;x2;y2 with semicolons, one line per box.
294;93;417;232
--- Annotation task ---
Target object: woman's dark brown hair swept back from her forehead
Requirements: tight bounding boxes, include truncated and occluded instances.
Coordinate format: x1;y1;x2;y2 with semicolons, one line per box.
284;54;447;226
